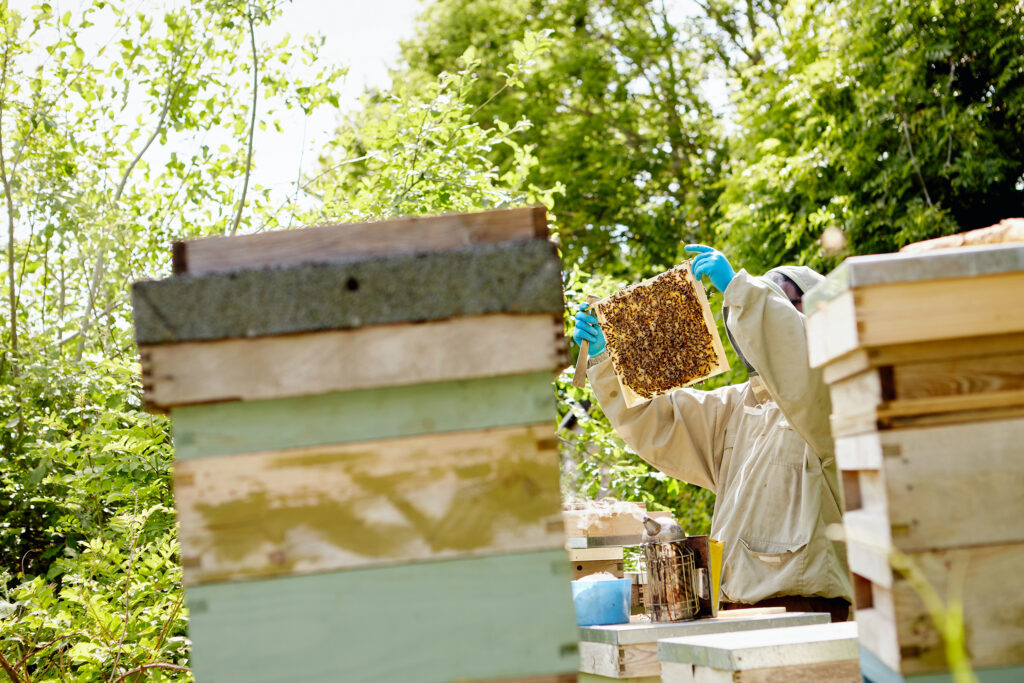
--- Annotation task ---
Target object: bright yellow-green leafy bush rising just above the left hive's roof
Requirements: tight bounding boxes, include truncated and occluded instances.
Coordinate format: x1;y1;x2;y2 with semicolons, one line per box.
282;31;562;223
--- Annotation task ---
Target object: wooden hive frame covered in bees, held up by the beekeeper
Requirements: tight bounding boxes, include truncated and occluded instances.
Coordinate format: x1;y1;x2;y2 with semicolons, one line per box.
594;261;729;408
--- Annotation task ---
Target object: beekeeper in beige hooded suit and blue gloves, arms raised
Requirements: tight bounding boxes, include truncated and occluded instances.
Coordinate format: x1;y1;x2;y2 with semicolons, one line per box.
572;245;852;621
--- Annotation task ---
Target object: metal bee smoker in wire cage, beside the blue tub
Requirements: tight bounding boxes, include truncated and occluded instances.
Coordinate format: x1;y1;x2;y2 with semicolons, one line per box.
640;516;705;622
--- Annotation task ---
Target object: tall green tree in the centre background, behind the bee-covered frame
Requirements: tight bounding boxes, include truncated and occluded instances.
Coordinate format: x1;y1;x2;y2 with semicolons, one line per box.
399;0;721;280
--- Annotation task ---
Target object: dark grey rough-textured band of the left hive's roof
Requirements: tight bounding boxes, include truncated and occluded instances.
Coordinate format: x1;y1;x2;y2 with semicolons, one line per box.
132;240;563;344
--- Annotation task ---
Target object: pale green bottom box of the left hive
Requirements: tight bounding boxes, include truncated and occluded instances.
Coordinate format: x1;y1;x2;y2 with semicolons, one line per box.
186;550;578;683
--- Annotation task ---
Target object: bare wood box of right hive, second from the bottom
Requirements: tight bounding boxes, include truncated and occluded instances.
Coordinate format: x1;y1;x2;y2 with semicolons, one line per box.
836;419;1024;552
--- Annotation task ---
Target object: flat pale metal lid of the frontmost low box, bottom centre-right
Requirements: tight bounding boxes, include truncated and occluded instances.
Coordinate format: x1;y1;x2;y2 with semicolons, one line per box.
658;622;857;671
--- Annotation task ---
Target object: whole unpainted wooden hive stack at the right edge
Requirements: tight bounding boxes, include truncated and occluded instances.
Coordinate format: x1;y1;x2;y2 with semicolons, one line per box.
804;245;1024;680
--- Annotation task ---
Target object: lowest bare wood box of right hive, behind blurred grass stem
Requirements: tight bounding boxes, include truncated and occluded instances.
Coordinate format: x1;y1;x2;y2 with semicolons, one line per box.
850;544;1024;675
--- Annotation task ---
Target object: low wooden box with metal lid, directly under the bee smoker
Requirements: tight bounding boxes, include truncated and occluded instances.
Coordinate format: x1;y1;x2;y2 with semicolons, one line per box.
580;607;828;679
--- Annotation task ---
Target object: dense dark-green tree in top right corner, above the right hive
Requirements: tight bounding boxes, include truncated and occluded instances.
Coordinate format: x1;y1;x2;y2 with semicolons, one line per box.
717;0;1024;270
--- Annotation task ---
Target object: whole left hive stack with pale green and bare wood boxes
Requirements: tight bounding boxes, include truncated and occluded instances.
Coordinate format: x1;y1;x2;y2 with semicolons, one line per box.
133;209;577;683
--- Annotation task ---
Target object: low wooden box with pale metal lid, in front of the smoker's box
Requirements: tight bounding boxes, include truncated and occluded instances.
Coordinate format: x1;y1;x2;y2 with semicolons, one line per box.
657;622;861;683
